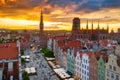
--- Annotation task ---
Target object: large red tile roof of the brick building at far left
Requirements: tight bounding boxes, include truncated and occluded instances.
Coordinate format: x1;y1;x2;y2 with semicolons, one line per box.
0;47;18;60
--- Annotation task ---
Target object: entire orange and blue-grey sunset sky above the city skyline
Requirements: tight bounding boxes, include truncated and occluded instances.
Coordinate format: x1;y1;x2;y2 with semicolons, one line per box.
0;0;120;32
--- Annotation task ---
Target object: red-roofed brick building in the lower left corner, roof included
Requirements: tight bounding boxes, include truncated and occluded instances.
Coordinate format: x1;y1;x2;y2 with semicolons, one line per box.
0;47;19;80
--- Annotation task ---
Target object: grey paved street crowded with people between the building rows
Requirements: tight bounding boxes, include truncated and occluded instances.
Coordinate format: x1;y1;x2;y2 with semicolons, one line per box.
25;50;59;80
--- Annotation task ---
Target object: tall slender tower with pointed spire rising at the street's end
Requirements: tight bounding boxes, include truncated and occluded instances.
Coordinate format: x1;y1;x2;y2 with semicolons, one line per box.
39;11;47;48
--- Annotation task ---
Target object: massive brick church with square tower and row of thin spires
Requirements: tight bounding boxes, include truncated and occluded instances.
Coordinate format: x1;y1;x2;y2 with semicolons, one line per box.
71;18;109;41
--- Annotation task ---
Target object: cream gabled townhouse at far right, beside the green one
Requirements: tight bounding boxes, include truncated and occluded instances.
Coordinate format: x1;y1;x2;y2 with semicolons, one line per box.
105;54;120;80
